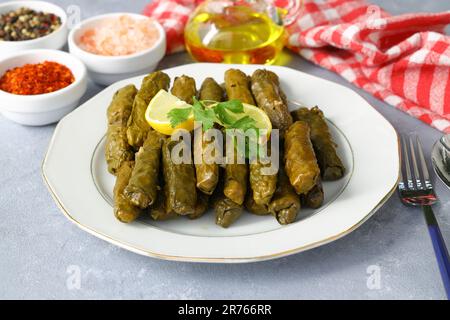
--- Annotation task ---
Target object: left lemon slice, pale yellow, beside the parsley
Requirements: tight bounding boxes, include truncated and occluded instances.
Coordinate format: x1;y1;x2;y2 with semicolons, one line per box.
145;90;194;135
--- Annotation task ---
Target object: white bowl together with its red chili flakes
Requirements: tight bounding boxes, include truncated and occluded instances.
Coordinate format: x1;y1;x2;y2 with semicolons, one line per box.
0;49;87;126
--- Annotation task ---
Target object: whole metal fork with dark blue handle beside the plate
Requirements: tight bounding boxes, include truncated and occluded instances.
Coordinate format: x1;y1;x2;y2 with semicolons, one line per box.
398;136;450;299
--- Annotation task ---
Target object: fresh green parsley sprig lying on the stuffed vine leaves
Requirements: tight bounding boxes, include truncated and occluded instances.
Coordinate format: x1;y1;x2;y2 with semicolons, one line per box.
167;97;256;131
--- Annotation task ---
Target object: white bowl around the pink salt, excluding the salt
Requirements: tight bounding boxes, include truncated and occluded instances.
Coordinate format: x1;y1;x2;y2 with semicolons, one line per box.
68;13;166;85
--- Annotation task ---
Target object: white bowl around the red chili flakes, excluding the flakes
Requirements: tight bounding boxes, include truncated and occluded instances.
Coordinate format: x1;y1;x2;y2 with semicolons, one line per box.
0;49;87;126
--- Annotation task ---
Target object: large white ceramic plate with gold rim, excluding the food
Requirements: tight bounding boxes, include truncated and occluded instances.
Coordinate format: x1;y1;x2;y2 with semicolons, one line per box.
42;63;399;263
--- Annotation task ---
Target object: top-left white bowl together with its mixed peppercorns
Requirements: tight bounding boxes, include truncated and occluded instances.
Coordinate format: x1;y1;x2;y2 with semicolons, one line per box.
0;1;68;55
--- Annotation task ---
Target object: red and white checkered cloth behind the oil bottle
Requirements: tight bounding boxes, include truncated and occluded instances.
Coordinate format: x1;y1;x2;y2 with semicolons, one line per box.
144;0;450;133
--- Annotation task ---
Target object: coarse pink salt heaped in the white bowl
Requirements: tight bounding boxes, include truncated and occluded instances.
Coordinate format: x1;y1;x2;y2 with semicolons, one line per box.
79;15;159;56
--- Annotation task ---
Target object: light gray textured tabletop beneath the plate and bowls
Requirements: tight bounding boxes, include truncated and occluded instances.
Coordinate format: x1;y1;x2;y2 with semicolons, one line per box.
0;0;450;299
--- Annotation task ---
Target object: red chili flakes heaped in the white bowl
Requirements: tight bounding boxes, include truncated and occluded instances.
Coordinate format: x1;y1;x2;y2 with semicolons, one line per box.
0;61;75;95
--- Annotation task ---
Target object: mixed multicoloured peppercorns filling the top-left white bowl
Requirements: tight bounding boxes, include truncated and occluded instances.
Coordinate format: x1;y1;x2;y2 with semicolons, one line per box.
0;8;61;41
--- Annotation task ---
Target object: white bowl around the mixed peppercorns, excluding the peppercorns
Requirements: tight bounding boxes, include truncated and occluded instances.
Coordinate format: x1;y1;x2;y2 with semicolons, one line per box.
0;1;68;55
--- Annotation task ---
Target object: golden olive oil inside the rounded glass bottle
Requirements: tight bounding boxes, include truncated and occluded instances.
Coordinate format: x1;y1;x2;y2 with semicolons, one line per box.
184;6;285;64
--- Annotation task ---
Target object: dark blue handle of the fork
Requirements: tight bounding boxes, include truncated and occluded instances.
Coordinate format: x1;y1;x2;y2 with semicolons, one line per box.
423;206;450;299
